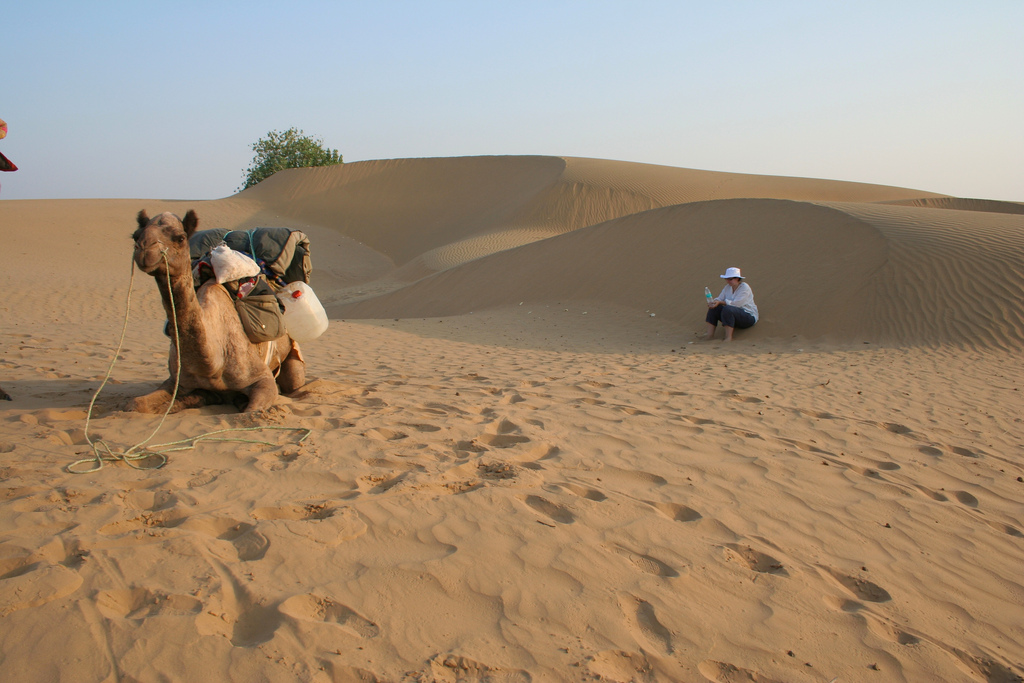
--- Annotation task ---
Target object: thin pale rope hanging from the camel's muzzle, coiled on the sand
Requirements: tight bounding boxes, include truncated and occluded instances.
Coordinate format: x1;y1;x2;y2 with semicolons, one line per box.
65;247;312;474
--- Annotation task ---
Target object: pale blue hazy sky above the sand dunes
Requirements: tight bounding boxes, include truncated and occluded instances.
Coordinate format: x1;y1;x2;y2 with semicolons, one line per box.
6;0;1024;202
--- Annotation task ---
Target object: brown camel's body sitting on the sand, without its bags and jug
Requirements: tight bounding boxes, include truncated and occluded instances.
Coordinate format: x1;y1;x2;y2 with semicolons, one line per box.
129;210;305;413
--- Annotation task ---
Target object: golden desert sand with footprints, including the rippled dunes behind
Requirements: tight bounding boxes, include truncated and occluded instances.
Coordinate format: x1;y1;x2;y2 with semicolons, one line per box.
0;157;1024;683
